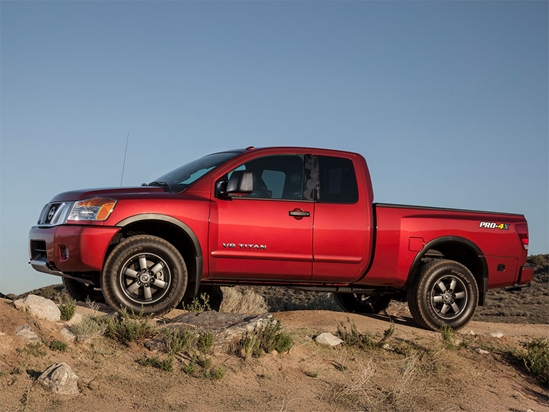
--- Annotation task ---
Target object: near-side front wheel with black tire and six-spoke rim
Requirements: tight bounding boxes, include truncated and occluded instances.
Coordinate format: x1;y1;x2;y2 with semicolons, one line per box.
101;235;187;316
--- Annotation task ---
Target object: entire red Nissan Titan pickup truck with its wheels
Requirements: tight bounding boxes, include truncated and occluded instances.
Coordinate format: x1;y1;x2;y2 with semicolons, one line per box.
29;147;533;329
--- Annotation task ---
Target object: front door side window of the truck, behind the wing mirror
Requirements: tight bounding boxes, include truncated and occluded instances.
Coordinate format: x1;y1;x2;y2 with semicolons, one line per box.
225;155;304;200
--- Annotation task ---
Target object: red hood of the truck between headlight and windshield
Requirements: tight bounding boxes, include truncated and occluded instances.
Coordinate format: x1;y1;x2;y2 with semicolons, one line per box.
51;186;168;203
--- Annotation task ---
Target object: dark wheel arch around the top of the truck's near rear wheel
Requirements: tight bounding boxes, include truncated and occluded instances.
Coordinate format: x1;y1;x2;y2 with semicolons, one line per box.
405;236;488;306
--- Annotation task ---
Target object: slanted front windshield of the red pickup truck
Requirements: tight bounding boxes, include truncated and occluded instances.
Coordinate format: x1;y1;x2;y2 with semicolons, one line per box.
149;152;242;192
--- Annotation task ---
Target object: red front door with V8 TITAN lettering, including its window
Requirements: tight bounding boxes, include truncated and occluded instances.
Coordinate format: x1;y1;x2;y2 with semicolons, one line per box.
209;155;314;282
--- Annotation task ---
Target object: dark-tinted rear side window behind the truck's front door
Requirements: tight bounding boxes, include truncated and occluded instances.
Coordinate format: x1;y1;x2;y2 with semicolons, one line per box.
318;156;358;203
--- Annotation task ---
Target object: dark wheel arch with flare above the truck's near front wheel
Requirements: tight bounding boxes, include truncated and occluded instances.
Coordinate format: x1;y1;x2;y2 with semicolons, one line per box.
113;213;203;296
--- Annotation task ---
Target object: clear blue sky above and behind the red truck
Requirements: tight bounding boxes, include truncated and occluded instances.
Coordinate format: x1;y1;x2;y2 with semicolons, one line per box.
0;1;549;293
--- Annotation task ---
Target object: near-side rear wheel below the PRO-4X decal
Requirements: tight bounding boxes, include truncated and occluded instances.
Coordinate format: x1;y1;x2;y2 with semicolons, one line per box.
408;259;478;330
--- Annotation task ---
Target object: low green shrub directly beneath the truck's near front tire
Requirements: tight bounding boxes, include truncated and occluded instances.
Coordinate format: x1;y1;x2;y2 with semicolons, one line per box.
105;311;158;344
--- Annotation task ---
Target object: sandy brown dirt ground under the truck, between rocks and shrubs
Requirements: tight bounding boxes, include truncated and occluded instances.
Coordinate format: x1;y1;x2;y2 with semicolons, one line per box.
0;301;549;412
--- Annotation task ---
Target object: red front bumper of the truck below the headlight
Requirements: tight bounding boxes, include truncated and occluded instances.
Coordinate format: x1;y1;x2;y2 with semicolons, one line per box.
29;225;120;276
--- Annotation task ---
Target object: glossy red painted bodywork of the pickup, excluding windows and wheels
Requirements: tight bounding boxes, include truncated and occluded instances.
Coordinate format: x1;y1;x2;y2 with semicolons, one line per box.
30;148;532;296
